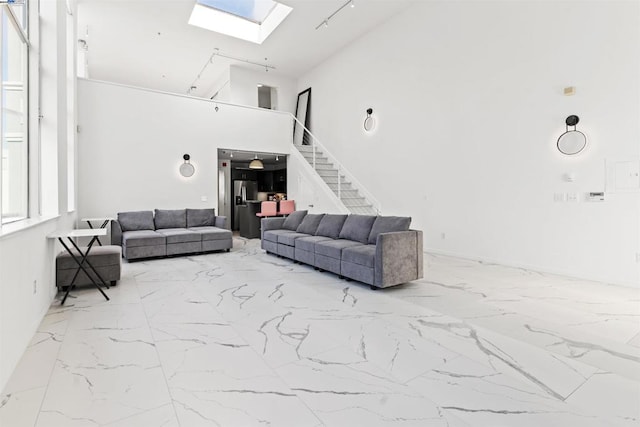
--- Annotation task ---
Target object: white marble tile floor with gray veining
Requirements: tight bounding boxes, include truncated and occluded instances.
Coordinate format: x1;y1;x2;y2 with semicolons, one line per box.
0;238;640;427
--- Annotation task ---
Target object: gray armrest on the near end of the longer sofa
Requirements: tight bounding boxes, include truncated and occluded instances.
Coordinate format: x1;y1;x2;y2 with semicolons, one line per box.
374;230;424;288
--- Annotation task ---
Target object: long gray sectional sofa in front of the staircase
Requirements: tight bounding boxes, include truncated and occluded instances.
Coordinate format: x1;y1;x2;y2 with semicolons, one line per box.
261;211;424;289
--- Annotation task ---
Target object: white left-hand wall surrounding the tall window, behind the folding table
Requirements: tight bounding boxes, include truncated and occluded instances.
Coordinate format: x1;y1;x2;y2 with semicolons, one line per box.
0;1;76;394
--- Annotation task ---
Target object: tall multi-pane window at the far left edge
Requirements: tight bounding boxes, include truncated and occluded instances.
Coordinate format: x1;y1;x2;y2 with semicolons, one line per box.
0;1;29;224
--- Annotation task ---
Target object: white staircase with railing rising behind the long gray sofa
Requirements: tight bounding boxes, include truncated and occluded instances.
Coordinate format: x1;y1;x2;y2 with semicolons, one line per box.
294;144;378;215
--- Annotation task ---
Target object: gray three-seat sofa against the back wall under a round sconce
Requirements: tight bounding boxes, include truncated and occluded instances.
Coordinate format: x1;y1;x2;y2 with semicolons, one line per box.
111;209;233;260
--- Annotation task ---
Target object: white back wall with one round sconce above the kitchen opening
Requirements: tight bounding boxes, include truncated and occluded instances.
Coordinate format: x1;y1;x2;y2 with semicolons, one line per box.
78;80;292;218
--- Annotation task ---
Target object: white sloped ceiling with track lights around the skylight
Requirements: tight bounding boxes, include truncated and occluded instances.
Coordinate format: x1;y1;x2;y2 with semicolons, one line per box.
78;0;416;97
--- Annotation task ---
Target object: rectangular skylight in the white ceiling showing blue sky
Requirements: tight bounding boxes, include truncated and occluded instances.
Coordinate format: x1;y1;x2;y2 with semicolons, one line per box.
189;0;292;44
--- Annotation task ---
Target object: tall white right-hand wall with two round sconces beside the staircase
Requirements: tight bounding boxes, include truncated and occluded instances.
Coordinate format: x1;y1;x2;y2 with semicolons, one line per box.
298;1;640;285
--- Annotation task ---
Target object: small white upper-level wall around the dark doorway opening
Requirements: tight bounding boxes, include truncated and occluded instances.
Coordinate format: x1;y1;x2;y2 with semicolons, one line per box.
230;65;298;114
